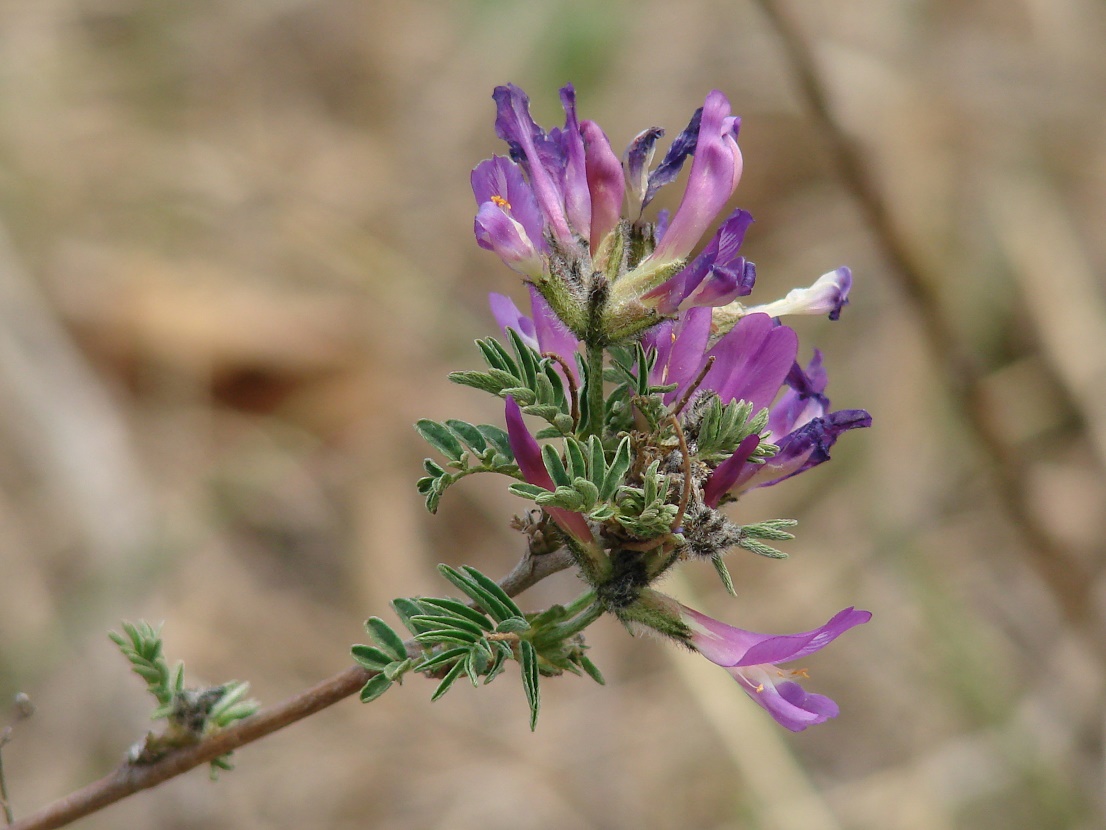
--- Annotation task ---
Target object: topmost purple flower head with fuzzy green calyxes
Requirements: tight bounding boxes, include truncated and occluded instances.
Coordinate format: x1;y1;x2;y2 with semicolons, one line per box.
472;84;755;336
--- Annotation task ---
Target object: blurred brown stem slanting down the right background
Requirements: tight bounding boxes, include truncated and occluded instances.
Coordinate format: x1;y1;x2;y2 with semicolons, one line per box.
758;0;1106;646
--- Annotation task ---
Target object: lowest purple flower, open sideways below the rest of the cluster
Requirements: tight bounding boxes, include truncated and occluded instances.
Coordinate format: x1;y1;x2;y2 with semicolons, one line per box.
680;605;872;732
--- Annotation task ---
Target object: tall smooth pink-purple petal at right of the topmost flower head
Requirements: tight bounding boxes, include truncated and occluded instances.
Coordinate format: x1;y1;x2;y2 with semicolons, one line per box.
651;90;742;262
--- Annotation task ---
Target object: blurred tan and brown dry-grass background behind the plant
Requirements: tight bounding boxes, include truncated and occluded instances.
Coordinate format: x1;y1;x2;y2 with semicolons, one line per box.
0;0;1106;830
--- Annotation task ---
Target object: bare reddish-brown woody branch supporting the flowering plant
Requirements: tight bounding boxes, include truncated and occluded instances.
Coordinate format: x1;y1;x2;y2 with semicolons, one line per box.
7;550;573;830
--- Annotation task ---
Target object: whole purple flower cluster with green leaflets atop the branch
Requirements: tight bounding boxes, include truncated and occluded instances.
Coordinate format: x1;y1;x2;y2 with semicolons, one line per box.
419;85;872;730
